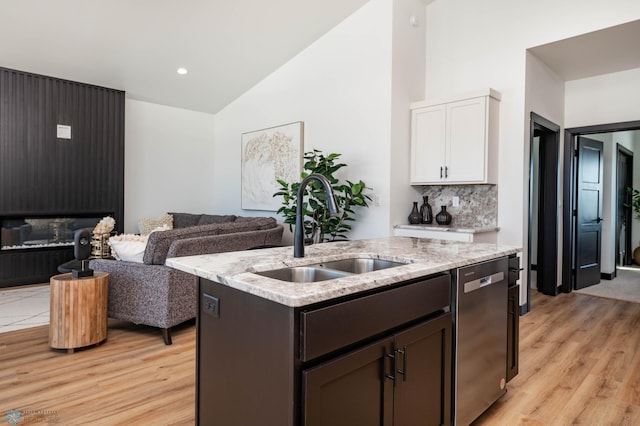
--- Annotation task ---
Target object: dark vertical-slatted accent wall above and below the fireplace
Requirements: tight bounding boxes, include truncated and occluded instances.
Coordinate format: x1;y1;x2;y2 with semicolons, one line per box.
0;68;125;287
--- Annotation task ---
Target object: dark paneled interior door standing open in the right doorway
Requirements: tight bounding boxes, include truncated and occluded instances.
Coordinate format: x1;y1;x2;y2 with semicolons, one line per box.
576;136;604;289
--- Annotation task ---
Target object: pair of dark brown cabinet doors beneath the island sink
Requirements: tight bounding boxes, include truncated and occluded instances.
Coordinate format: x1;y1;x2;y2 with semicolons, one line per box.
302;314;451;426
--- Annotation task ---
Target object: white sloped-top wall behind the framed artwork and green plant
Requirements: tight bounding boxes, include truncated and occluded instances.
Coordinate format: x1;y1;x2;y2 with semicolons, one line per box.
211;0;408;241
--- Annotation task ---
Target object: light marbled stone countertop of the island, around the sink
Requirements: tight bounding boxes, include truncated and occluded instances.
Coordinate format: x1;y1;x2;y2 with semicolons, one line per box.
166;237;520;307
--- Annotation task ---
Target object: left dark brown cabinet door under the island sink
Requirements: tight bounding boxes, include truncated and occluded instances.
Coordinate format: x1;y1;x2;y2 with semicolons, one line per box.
302;338;393;426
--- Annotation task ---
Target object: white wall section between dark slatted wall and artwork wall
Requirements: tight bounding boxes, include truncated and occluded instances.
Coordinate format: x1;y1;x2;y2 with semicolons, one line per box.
124;99;214;233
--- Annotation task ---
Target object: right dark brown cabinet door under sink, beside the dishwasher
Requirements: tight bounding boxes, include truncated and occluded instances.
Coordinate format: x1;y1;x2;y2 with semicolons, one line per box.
393;314;451;426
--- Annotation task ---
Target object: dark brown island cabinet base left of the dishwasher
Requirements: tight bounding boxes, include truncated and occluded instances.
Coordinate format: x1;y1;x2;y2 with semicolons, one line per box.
196;274;452;426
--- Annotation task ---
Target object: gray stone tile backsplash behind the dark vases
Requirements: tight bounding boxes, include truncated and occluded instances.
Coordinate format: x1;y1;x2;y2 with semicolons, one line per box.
418;185;498;228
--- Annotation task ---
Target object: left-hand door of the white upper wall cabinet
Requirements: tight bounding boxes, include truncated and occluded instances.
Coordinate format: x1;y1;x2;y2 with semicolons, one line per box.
411;105;446;184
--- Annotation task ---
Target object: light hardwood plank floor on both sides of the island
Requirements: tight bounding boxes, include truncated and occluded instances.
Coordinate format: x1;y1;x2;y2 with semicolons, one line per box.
0;293;640;426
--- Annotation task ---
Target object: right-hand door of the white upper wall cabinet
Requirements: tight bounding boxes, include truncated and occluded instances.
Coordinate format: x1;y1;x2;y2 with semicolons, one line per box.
445;96;488;183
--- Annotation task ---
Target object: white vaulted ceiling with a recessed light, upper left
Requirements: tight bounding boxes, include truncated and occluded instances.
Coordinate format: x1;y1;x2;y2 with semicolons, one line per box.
0;0;367;113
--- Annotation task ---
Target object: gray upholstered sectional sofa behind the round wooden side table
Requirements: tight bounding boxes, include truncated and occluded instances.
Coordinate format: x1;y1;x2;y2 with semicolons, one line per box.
90;213;283;345
